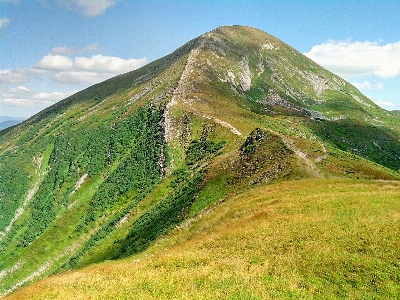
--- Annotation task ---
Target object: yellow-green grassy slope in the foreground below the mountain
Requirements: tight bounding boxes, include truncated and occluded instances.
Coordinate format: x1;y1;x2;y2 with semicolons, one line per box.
5;179;400;299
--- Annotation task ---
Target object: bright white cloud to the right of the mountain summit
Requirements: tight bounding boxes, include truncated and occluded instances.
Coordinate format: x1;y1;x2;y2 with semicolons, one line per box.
304;41;400;78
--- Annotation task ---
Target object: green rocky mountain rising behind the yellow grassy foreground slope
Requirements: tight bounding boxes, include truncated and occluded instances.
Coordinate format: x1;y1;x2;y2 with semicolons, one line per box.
0;26;400;299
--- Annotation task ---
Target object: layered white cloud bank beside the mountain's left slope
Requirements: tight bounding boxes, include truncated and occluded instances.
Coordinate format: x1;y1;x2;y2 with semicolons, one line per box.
0;40;147;116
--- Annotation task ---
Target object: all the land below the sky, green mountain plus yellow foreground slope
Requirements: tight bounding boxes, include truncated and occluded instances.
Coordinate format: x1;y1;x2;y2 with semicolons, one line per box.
0;26;400;299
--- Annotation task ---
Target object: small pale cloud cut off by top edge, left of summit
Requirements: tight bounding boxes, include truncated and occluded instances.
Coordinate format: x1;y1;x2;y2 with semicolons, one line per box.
57;0;117;17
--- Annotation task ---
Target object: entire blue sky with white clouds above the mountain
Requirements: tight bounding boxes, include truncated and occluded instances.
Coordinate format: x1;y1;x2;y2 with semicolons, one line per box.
0;0;400;118
